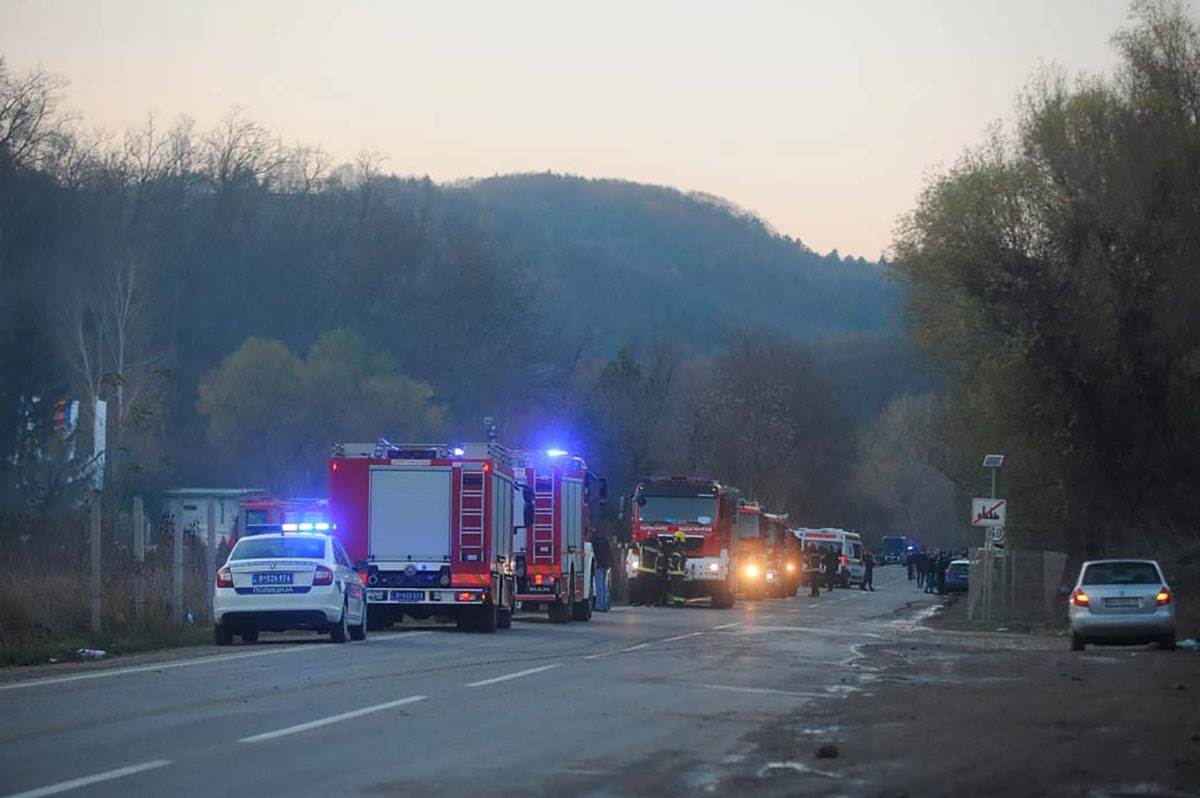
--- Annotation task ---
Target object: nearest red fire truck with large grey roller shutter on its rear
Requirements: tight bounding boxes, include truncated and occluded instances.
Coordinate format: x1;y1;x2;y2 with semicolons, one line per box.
329;439;533;632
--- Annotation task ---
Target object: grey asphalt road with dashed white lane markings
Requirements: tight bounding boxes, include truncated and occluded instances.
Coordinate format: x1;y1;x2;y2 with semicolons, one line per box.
0;568;934;797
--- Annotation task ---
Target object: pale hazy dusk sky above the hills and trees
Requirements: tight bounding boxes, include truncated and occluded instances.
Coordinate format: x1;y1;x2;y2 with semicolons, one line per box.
0;0;1161;258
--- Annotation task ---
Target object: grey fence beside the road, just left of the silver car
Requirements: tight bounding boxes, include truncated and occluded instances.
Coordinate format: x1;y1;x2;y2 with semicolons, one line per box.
967;548;1067;622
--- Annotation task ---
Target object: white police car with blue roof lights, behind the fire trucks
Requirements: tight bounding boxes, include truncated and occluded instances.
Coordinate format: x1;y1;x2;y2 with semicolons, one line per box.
212;532;367;646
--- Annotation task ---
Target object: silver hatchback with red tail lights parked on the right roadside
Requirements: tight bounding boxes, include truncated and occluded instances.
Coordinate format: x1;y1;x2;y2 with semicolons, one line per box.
1069;559;1175;652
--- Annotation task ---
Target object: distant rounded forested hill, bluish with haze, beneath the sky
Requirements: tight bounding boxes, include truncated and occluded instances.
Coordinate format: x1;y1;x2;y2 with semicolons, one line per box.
460;174;898;350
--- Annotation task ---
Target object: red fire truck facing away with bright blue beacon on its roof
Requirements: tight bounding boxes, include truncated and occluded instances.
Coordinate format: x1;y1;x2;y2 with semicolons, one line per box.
512;449;607;624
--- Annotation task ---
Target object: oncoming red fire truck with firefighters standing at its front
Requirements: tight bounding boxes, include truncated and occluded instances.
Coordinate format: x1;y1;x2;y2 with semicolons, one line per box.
625;476;738;610
